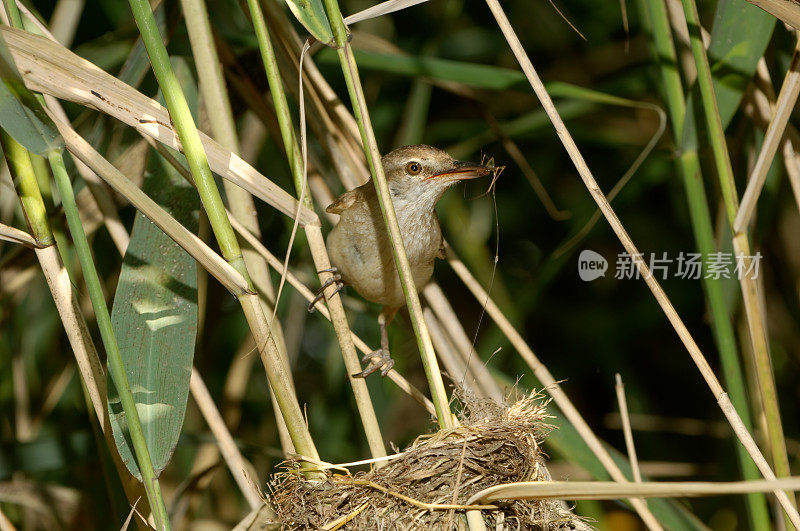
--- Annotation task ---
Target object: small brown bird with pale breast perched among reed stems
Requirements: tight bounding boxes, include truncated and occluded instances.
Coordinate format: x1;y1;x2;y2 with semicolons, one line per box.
318;145;493;378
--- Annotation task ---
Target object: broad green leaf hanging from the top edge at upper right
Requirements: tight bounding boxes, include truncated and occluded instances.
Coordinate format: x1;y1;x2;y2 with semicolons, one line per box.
708;0;775;127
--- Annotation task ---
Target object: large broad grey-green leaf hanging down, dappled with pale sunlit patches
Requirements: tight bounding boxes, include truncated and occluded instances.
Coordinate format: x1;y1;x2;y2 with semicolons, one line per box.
108;58;200;478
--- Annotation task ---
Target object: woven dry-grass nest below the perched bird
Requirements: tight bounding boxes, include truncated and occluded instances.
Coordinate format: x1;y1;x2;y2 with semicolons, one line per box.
271;395;587;530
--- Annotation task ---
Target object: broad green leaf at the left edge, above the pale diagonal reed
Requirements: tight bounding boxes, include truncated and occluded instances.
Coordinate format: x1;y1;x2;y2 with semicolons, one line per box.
0;35;62;155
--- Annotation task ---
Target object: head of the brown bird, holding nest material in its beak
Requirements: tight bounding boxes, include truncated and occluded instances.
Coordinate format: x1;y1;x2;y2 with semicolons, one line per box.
382;144;492;208
